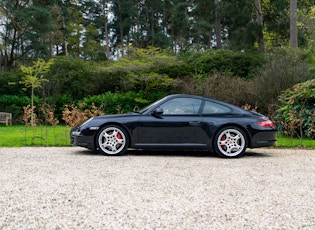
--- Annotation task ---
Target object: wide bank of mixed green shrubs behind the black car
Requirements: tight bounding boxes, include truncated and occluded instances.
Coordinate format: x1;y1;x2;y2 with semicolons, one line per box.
2;47;315;123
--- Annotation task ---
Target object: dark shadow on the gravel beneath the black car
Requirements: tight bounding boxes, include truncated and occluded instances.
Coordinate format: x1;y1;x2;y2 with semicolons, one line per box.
74;149;271;158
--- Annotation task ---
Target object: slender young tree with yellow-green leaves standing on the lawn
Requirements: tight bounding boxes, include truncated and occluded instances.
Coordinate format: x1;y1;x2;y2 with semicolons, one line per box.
20;59;53;126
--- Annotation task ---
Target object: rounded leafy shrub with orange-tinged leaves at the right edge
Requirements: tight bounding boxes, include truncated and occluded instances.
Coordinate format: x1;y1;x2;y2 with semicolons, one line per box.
276;79;315;138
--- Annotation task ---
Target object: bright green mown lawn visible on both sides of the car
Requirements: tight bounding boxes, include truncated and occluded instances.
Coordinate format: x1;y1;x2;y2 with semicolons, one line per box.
0;125;315;148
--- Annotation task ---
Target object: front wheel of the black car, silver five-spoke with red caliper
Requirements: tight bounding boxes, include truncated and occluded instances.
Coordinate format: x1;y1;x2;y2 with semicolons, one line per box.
96;125;129;156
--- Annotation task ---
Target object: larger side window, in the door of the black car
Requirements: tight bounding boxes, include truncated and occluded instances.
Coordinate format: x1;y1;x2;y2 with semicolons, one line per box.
160;98;201;115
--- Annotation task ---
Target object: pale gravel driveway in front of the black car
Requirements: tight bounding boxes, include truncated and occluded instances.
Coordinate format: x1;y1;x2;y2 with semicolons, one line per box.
0;147;315;230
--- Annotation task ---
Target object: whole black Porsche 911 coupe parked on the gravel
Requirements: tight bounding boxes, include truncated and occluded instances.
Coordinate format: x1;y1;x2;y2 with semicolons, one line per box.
70;94;277;158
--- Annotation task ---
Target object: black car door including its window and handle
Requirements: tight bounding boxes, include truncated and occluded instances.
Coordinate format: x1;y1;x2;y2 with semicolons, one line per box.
137;97;208;148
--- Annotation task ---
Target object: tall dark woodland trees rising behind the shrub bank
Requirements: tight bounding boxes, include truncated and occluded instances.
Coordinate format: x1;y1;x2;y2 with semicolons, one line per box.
0;0;314;71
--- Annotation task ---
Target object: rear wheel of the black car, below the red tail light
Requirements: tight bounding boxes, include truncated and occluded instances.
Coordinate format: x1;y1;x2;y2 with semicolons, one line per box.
214;126;247;157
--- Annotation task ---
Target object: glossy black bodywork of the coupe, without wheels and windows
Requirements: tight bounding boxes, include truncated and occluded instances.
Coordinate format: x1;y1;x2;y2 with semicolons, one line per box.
70;95;276;155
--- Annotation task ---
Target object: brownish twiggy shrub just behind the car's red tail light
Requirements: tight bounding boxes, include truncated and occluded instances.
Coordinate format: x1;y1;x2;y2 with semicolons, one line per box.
251;49;312;116
